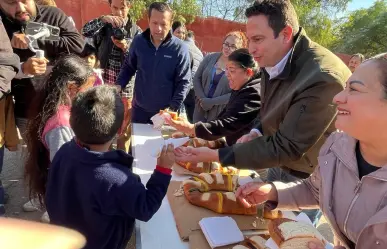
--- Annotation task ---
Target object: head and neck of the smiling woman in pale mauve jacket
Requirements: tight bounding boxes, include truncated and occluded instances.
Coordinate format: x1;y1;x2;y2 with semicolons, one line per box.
333;54;387;148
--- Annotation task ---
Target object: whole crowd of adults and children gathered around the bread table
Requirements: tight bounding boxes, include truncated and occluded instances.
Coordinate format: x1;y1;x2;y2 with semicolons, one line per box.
0;0;387;249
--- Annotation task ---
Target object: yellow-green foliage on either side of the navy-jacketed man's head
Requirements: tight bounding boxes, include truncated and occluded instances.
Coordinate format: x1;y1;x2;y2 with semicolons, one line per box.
129;0;200;24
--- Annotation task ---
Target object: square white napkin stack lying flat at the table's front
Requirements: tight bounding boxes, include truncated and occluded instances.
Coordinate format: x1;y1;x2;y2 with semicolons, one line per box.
199;216;244;248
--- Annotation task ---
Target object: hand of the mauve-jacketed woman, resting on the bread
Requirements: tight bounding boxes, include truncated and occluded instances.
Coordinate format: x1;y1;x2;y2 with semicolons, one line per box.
235;182;278;208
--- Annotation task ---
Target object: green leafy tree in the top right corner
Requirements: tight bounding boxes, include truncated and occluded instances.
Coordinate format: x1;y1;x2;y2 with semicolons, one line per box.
335;0;387;56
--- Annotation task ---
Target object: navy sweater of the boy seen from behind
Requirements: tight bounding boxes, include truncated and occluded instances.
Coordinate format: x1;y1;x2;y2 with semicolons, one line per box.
46;140;171;249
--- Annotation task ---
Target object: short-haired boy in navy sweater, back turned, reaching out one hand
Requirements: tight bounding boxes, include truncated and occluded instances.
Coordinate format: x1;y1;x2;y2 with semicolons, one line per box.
46;85;175;249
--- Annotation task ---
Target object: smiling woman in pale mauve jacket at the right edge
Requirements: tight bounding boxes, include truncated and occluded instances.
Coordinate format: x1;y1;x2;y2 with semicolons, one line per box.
224;54;387;249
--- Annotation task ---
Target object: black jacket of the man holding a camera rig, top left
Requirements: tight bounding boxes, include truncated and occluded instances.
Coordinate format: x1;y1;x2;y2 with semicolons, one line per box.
0;5;84;118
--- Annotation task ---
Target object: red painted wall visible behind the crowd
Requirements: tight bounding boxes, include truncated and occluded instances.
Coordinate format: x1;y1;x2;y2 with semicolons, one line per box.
56;0;350;64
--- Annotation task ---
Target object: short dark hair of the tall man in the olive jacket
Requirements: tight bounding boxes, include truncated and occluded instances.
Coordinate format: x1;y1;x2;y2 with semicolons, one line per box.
245;0;300;38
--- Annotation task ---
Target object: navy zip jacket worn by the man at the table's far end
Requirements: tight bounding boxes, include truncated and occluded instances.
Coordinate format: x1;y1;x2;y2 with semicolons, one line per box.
117;29;191;112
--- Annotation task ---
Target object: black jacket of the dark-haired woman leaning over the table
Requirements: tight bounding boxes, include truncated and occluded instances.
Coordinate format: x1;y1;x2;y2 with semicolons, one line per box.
195;75;261;146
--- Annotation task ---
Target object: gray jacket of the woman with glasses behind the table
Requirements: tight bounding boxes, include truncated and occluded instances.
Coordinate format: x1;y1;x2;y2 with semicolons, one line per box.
193;53;231;122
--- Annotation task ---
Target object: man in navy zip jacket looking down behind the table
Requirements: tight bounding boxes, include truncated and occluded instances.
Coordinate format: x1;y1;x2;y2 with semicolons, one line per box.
117;2;191;123
